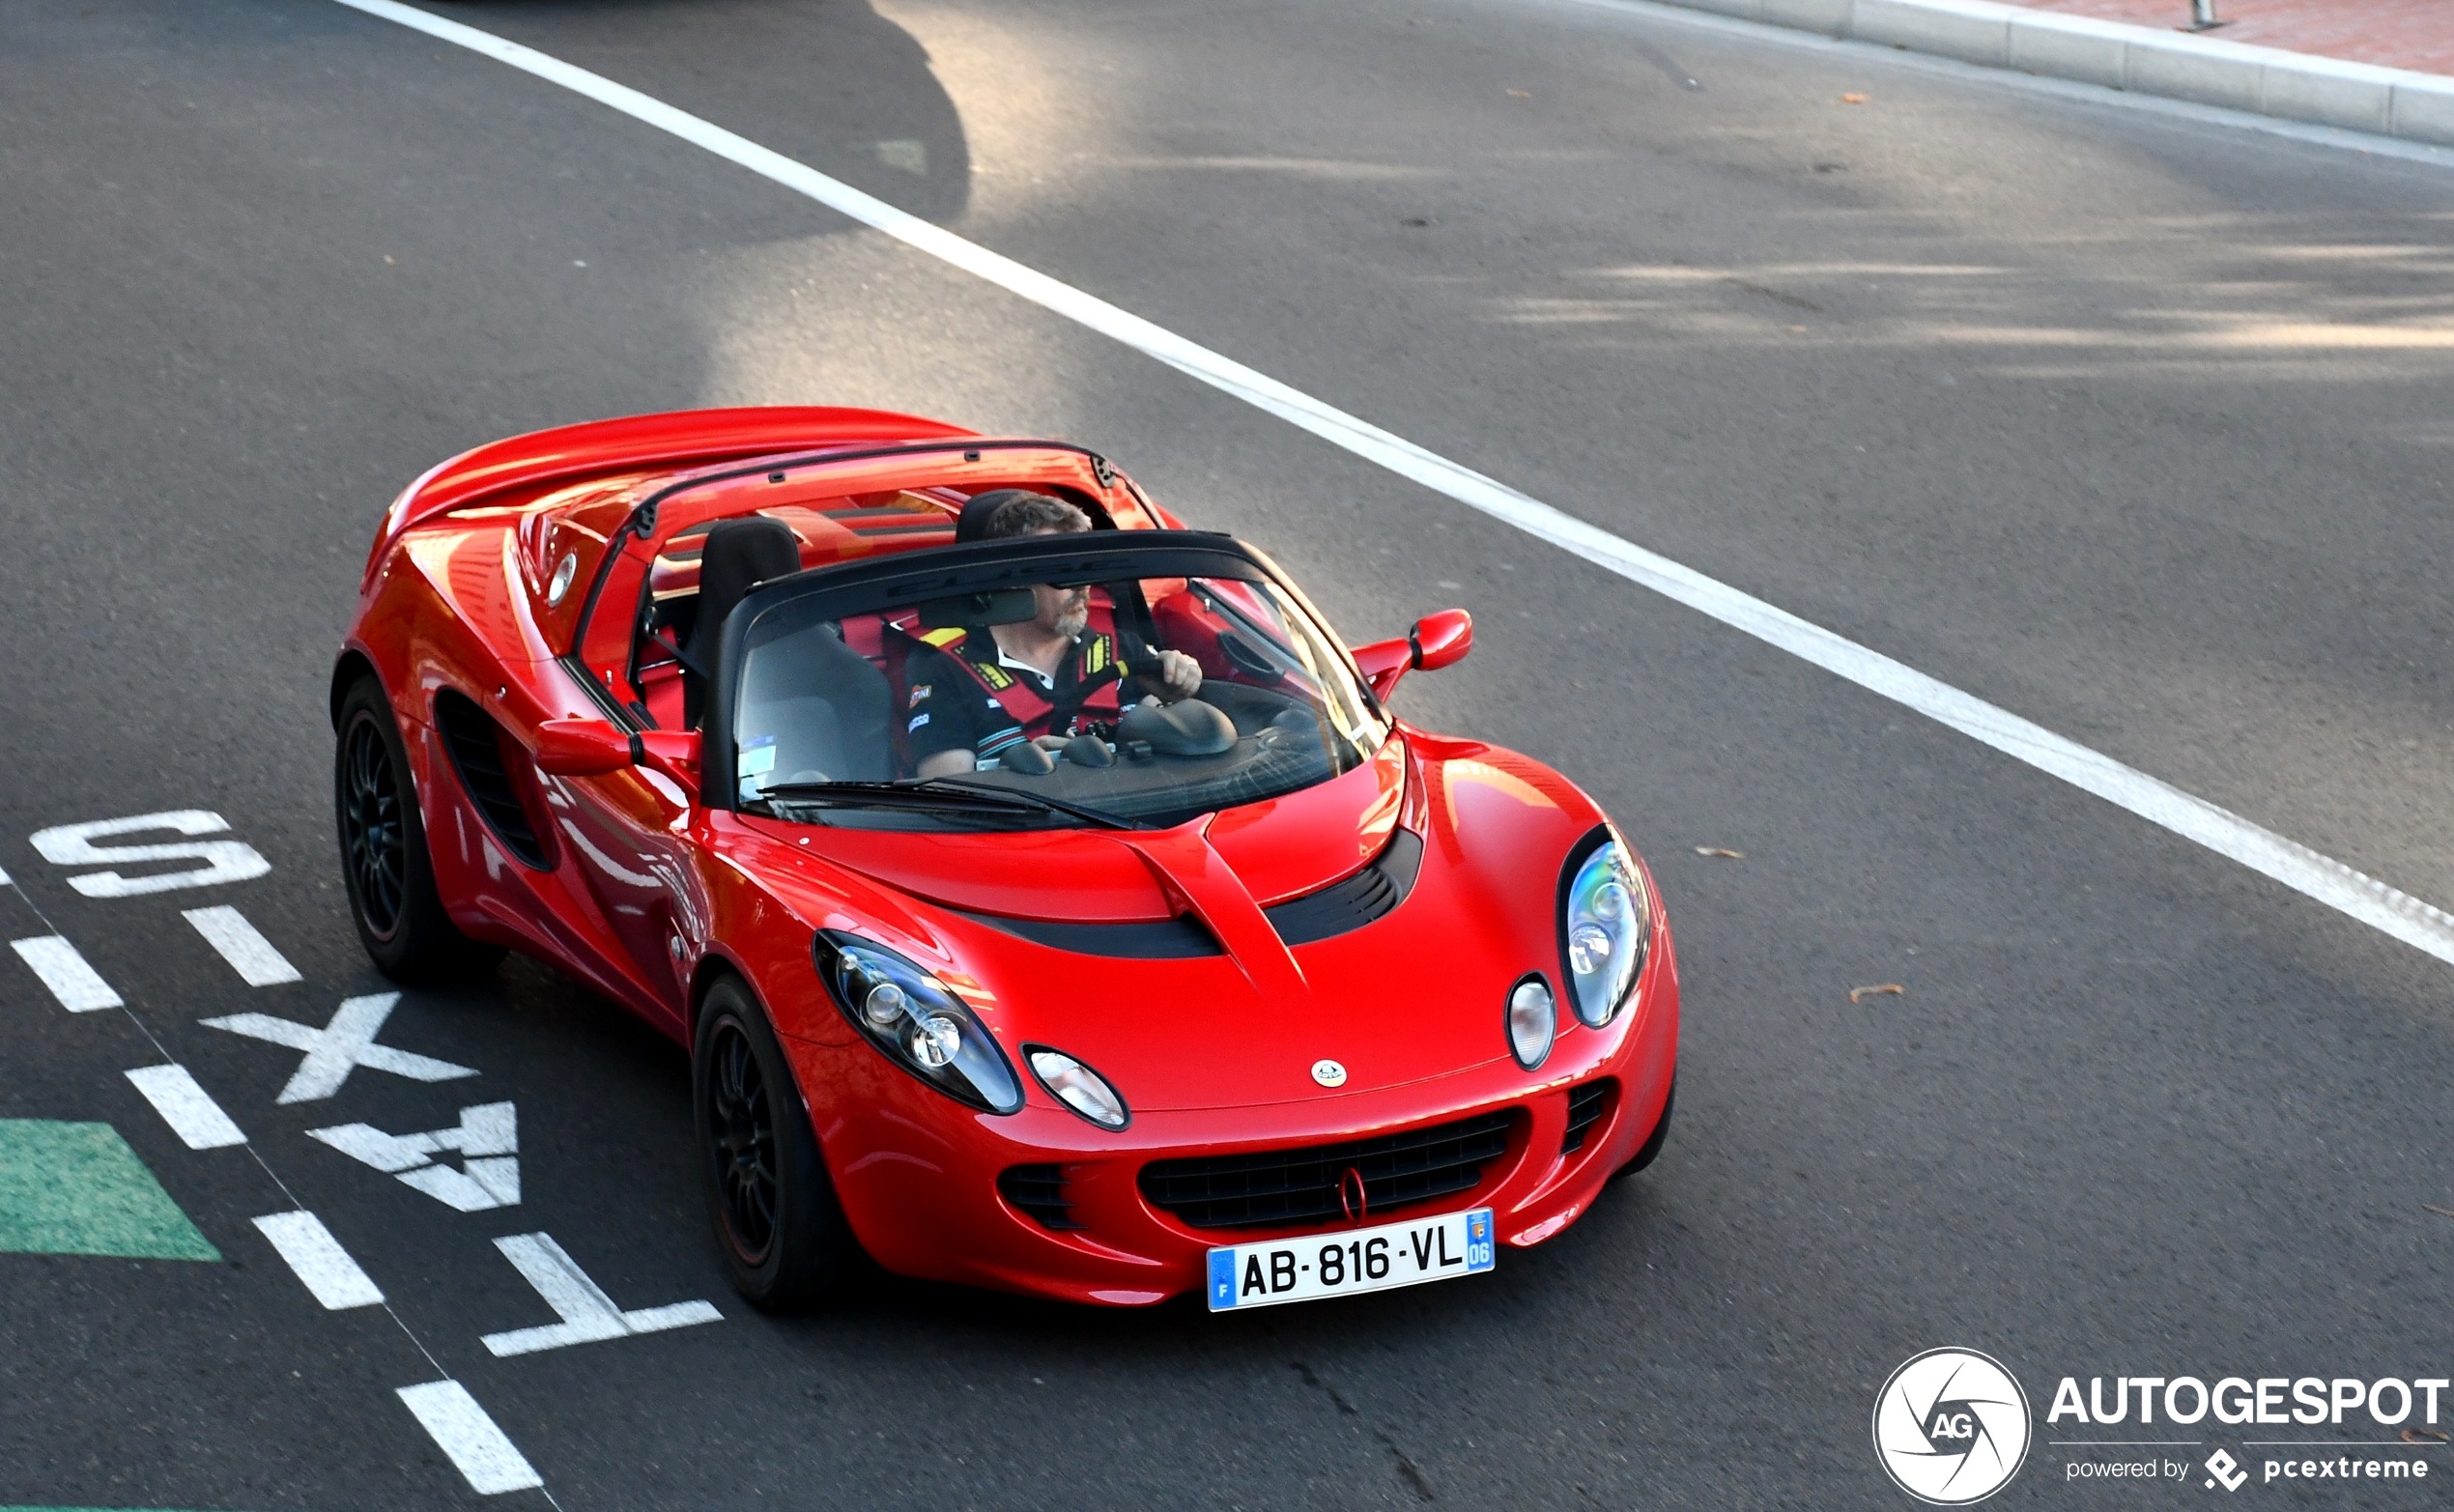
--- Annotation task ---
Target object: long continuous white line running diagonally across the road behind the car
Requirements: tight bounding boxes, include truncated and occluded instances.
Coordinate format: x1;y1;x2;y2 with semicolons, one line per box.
336;0;2454;962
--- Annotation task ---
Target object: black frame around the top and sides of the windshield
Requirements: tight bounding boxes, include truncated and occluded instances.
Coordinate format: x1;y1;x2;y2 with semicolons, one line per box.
699;530;1389;810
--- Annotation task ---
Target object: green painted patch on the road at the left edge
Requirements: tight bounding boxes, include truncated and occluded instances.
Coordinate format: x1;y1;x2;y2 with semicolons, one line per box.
0;1120;221;1259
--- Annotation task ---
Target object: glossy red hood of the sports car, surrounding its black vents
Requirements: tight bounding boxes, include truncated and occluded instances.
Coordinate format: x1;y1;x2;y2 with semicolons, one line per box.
749;731;1622;1112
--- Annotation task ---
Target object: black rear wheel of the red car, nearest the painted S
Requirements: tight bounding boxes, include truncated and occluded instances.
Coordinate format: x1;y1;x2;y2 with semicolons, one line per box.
331;677;503;982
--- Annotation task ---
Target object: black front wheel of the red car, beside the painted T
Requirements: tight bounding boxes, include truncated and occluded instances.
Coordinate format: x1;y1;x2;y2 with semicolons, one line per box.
690;977;859;1311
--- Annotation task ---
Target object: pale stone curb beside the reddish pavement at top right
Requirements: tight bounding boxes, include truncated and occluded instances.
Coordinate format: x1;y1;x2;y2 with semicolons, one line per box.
1669;0;2454;145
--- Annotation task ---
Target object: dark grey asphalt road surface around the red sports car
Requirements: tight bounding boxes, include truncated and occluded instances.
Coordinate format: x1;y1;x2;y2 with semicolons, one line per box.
0;0;2454;1512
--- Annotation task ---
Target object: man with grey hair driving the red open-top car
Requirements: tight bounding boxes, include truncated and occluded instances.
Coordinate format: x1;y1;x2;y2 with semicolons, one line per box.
896;489;1203;778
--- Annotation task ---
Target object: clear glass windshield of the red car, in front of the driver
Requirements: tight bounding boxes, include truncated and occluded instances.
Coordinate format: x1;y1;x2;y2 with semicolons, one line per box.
712;532;1386;830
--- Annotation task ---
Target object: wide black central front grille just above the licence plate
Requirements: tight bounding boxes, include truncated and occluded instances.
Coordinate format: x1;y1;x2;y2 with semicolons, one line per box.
1141;1109;1517;1227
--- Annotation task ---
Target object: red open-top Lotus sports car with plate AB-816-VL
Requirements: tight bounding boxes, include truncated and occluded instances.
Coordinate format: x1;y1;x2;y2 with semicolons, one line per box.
331;410;1678;1308
